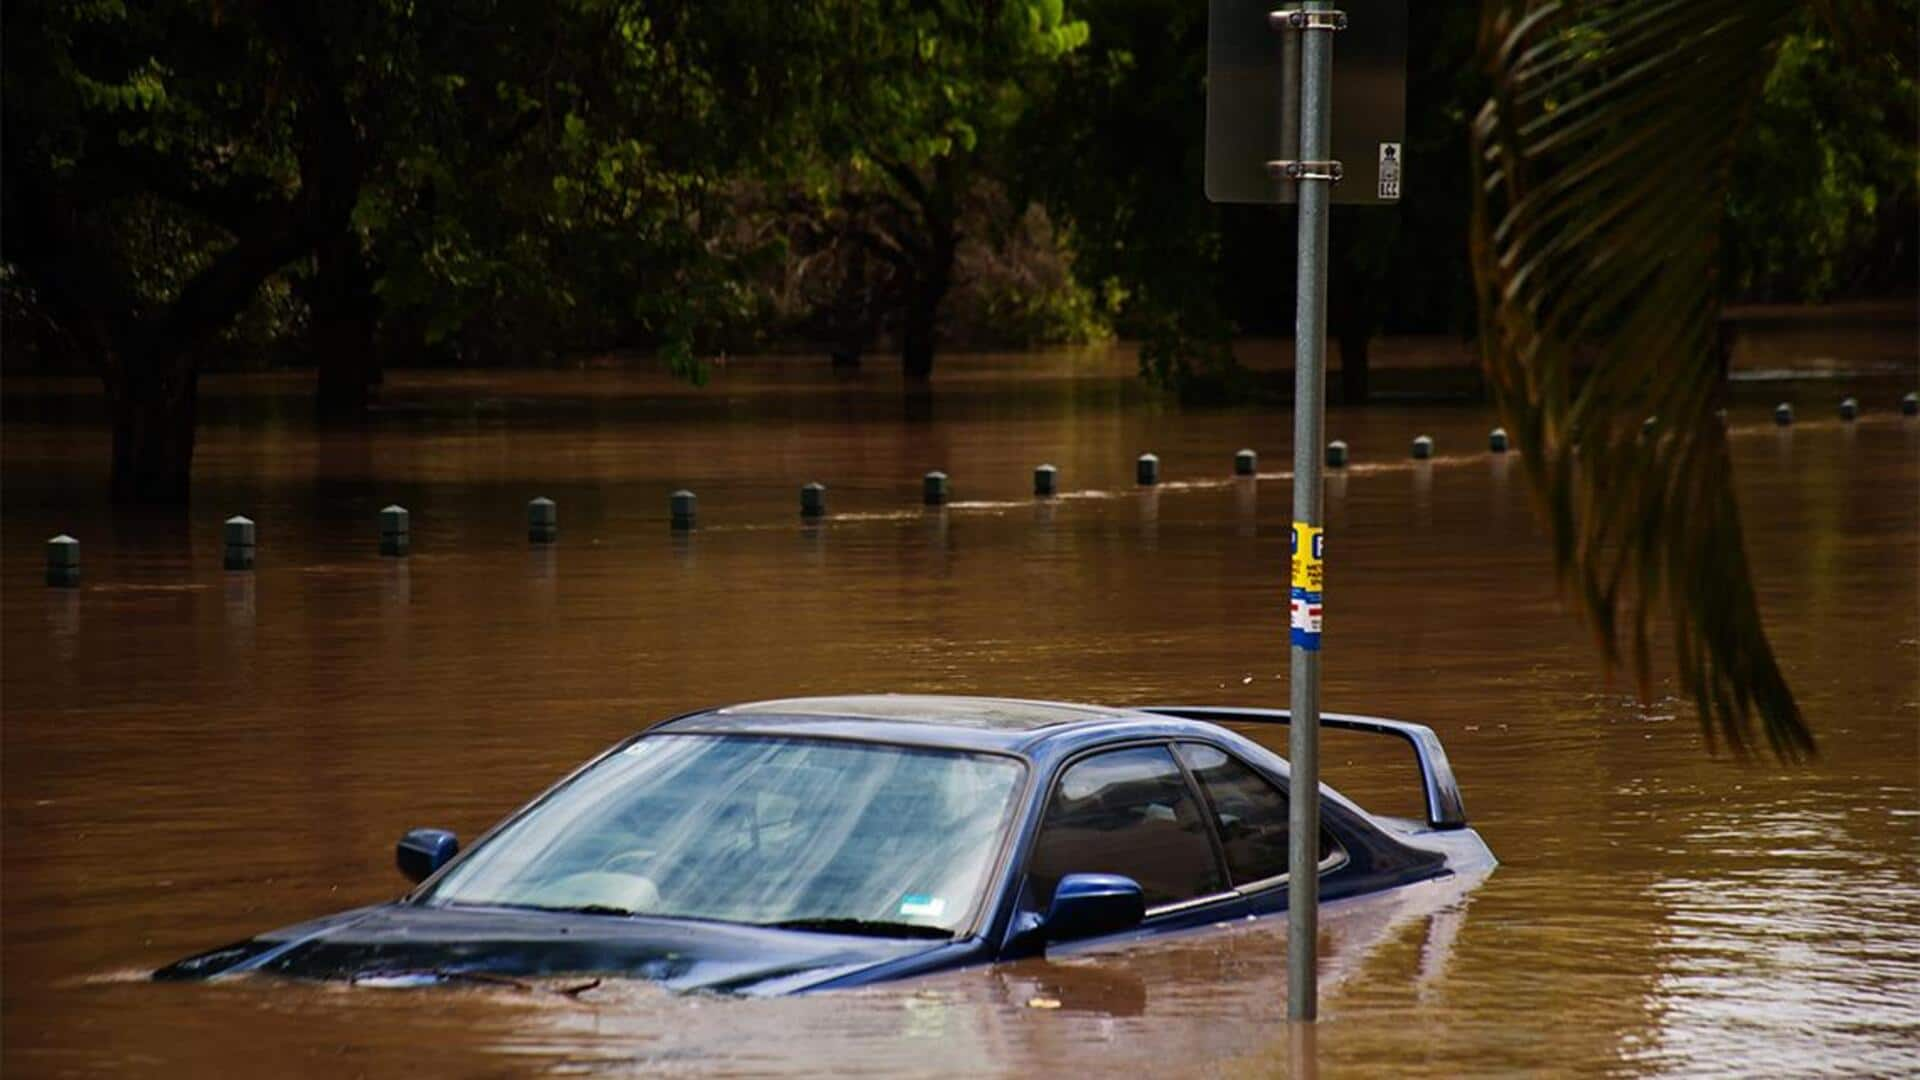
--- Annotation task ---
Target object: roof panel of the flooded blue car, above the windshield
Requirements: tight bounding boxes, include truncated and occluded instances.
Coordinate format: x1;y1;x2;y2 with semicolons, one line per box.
653;694;1188;753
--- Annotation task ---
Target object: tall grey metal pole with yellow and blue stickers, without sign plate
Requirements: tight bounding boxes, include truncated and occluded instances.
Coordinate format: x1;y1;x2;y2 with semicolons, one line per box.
1286;0;1336;1020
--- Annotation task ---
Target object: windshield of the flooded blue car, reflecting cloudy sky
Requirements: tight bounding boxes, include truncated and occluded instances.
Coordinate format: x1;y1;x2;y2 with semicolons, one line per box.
420;734;1023;936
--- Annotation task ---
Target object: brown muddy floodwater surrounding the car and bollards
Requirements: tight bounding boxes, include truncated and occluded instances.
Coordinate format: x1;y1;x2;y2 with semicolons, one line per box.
0;354;1920;1076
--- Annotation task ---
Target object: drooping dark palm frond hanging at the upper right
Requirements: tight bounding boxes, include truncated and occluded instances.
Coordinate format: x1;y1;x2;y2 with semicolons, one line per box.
1473;0;1814;759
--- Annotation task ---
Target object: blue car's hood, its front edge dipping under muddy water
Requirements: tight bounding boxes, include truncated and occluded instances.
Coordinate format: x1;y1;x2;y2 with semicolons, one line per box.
154;903;954;994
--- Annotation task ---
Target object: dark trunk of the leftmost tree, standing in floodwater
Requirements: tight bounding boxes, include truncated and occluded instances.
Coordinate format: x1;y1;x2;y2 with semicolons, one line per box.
104;356;200;505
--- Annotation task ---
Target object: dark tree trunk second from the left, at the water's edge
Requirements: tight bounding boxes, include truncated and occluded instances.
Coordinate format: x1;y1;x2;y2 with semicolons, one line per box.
309;231;380;421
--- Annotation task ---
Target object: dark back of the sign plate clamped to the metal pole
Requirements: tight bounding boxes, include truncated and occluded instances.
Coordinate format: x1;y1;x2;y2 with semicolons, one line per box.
1206;0;1419;206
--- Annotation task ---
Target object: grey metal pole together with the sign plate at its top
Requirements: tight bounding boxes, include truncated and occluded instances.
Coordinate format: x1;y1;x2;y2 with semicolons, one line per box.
1206;0;1407;1020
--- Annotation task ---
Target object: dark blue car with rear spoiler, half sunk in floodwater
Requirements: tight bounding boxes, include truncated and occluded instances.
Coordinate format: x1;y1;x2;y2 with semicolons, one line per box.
154;696;1494;994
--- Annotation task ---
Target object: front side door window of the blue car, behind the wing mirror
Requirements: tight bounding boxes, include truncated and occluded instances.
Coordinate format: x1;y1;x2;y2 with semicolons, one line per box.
1027;746;1225;907
